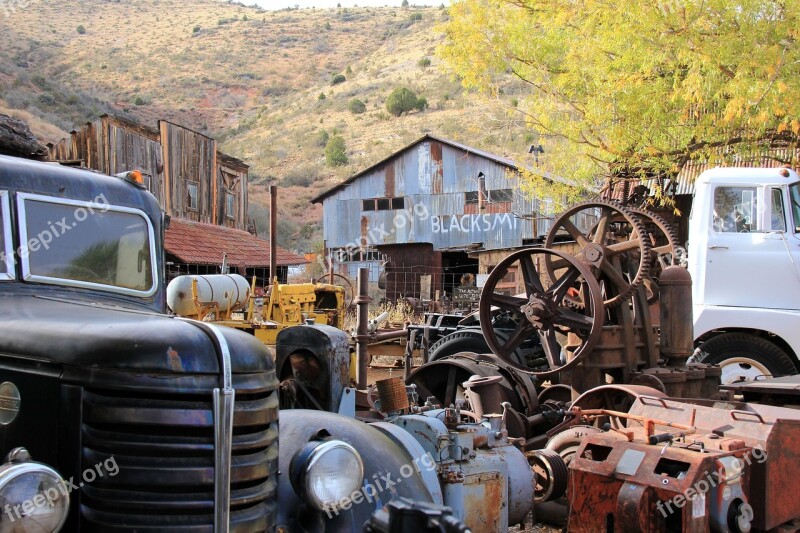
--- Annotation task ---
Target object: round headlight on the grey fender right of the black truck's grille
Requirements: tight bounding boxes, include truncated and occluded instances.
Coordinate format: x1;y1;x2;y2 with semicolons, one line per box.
290;440;364;512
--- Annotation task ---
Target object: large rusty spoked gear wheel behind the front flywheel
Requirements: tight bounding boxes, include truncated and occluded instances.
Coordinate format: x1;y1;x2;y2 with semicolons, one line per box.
544;200;651;305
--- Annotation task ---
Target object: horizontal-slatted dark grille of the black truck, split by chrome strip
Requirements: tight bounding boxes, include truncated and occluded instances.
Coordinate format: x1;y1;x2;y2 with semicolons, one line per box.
75;371;278;532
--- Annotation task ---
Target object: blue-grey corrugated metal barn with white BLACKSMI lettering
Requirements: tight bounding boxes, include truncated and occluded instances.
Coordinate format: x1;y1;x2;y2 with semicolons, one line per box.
312;135;550;299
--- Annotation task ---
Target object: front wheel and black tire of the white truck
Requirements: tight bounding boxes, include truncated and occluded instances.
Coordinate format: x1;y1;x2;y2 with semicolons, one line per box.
697;333;797;385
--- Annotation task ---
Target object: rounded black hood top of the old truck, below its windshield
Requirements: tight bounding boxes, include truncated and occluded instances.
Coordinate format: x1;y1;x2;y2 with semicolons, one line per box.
0;294;272;374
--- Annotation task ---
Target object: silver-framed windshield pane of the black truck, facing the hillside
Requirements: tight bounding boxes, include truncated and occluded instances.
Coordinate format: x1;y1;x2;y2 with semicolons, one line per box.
17;193;157;296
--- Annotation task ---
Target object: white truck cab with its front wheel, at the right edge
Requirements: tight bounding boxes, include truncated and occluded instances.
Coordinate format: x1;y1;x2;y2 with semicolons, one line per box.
688;168;800;383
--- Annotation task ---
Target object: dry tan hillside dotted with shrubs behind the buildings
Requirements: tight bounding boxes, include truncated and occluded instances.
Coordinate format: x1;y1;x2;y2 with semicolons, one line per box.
0;0;530;251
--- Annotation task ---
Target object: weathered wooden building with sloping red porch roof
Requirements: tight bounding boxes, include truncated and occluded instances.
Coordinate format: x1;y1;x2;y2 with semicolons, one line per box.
47;115;307;283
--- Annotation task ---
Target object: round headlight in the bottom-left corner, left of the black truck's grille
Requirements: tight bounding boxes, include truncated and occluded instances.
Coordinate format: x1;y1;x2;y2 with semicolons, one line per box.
0;448;69;533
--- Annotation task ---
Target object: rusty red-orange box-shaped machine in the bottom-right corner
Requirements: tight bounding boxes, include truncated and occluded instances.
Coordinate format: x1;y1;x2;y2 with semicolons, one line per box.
568;396;800;532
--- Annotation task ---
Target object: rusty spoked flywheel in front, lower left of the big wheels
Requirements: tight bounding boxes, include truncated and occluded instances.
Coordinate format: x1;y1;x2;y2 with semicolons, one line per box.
479;248;604;378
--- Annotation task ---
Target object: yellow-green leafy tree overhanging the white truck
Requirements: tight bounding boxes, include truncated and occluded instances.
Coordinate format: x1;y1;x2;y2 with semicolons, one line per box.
441;0;800;197
